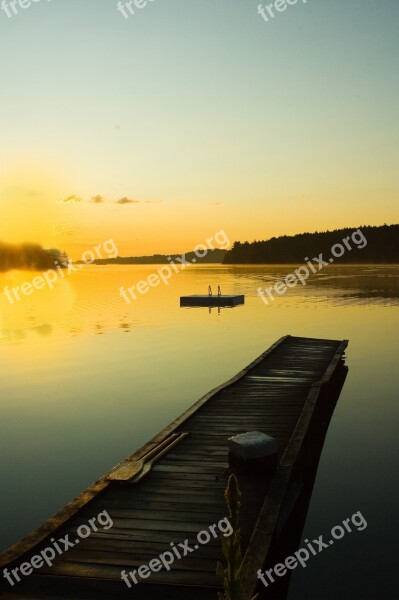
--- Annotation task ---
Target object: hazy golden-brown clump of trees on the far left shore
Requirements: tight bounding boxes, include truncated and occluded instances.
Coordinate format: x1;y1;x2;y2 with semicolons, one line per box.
0;242;68;271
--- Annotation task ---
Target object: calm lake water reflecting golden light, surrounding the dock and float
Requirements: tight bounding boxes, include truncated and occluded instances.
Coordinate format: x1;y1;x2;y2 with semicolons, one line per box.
0;265;399;600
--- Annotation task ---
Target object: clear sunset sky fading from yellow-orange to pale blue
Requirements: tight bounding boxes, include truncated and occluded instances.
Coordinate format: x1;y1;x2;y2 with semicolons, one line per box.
0;0;399;259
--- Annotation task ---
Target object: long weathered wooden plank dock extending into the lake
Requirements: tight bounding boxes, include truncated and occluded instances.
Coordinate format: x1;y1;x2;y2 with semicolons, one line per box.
0;336;347;600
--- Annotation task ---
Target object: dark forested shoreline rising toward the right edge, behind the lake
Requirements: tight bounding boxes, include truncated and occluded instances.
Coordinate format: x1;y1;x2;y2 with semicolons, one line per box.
223;225;399;264
